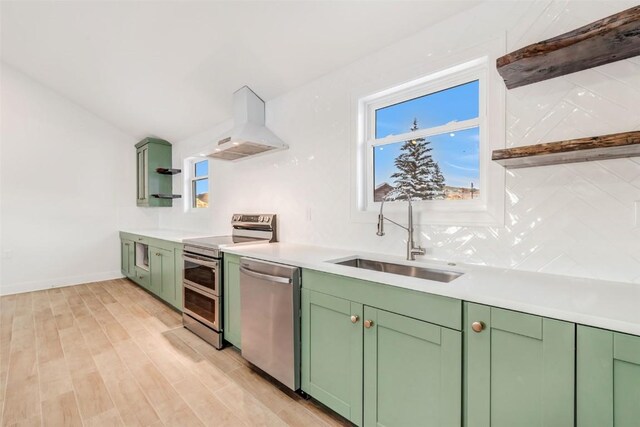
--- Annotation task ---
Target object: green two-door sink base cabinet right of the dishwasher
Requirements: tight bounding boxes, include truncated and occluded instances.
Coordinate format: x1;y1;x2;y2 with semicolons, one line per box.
301;270;462;427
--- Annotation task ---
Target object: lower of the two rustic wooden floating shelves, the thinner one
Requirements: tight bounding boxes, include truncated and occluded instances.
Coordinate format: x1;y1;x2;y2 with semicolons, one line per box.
491;131;640;169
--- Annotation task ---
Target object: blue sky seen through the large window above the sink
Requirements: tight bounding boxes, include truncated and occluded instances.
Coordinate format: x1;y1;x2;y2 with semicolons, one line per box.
374;81;480;188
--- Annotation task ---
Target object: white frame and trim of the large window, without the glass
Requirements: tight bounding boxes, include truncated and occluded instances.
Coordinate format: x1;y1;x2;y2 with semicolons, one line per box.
351;41;505;226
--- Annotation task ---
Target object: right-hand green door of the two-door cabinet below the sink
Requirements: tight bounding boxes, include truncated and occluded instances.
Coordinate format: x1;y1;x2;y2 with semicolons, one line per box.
364;307;462;427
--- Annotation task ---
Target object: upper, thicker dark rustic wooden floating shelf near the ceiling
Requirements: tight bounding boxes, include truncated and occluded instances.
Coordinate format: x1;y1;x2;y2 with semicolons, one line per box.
496;6;640;89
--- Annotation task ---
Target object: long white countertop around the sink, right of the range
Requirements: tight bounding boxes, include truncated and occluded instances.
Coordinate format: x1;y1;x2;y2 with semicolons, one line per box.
224;243;640;335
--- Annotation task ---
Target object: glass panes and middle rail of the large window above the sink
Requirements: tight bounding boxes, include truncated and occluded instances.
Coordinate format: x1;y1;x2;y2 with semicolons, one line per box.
368;80;480;202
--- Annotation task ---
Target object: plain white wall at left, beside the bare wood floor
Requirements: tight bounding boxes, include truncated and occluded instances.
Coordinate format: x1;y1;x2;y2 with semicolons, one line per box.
0;64;158;294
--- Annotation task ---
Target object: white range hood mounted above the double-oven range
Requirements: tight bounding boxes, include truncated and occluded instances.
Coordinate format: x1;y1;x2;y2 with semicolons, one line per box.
208;86;289;160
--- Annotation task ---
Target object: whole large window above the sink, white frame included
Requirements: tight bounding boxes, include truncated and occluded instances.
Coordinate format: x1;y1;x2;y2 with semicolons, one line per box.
352;51;504;225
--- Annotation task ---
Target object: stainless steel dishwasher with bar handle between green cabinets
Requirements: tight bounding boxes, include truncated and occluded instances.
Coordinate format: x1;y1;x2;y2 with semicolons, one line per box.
240;258;300;390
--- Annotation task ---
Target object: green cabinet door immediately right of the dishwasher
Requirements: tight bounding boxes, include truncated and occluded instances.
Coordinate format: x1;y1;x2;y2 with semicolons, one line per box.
301;289;363;425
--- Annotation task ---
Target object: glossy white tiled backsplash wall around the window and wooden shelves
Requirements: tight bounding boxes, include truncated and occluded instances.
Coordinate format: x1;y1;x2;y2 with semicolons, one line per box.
160;1;640;283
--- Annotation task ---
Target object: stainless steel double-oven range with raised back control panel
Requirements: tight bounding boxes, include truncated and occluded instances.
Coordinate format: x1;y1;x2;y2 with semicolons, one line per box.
182;214;276;349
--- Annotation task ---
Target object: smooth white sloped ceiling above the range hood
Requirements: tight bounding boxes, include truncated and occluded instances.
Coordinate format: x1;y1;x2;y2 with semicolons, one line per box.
0;0;479;141
